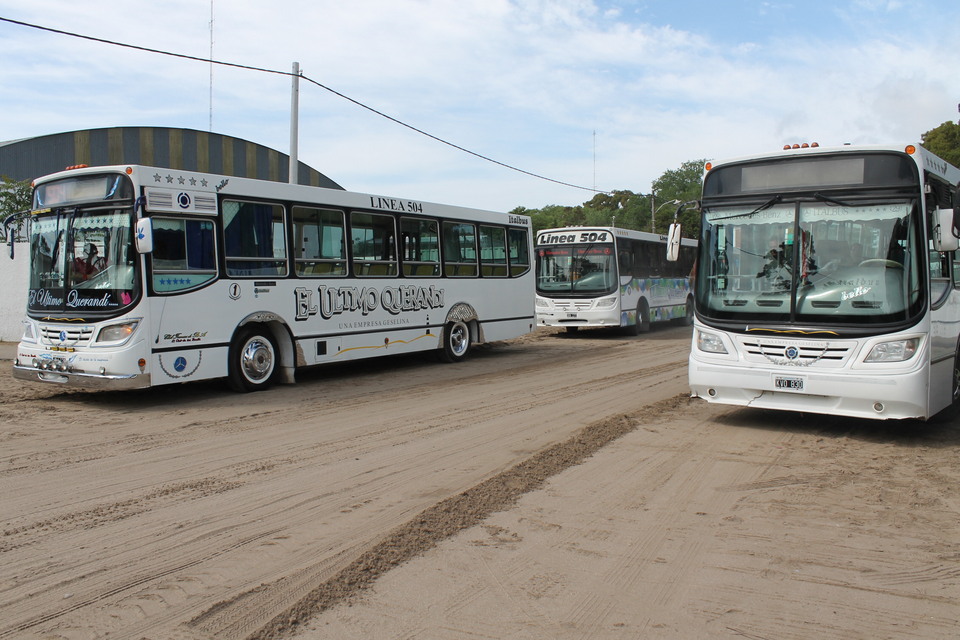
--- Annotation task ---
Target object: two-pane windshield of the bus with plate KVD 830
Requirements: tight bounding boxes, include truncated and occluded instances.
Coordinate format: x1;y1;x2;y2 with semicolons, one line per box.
696;196;924;325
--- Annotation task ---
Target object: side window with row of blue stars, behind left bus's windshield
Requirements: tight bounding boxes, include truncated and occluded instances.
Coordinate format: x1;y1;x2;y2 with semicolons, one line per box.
150;217;217;293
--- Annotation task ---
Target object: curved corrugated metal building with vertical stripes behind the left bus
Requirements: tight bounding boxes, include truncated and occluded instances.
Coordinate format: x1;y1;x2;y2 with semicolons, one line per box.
0;127;343;189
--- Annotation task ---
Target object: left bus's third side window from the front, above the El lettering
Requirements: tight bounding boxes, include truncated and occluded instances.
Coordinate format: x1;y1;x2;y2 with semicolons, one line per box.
292;207;347;277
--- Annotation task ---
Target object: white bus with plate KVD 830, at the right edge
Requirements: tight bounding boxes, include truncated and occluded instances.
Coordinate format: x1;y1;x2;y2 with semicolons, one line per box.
689;145;960;419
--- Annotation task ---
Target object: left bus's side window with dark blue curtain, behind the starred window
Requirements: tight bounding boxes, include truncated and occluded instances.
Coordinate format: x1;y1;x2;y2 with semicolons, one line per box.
223;200;287;276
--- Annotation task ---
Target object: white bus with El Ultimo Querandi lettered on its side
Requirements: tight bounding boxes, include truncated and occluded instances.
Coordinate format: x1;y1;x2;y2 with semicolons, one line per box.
11;166;535;391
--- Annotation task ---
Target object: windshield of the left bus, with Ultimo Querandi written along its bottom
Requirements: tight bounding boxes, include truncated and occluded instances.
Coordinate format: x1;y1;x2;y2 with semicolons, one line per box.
27;176;139;317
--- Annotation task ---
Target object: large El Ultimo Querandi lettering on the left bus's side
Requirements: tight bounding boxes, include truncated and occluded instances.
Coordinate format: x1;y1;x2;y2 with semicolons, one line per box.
294;285;444;320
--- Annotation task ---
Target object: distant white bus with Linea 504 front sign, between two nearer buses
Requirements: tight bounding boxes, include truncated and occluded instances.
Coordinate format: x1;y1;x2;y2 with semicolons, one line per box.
535;227;696;335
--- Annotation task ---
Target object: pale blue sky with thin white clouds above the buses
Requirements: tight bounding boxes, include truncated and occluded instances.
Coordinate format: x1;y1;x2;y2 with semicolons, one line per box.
0;0;960;211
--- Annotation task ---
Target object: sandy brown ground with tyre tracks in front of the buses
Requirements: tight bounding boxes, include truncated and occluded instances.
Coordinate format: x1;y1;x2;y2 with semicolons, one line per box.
0;327;960;640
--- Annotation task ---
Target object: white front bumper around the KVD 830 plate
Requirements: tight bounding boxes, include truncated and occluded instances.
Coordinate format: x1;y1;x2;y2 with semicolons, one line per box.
688;354;930;420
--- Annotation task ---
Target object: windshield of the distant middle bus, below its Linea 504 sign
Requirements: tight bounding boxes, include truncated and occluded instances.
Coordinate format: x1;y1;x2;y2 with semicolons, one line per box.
537;243;617;297
